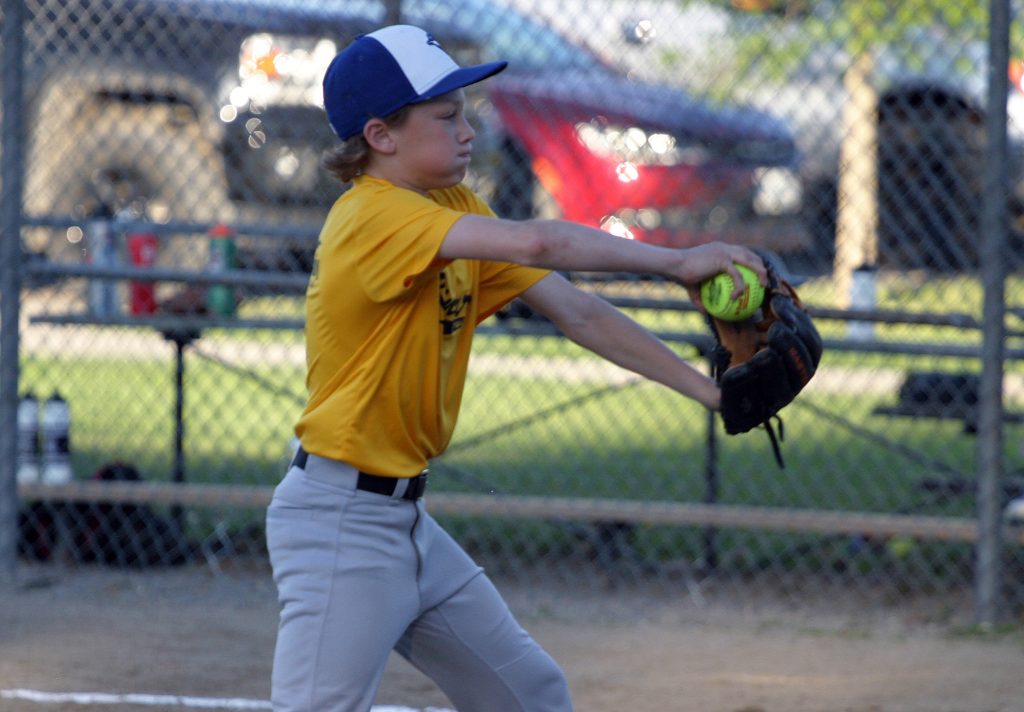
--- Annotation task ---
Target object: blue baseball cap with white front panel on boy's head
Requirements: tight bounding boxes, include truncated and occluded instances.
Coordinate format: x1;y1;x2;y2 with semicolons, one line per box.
324;25;508;140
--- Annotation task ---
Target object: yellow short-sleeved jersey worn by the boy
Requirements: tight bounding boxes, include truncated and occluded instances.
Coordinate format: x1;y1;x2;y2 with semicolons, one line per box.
296;176;548;476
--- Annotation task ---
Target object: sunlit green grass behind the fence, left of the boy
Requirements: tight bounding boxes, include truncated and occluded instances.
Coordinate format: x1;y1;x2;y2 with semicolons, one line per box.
22;357;302;484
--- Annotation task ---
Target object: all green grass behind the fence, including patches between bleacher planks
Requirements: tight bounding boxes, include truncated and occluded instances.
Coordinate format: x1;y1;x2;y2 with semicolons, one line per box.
22;272;1021;568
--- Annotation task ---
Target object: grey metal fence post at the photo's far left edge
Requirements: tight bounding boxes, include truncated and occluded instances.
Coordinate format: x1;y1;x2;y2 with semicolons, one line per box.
0;0;25;588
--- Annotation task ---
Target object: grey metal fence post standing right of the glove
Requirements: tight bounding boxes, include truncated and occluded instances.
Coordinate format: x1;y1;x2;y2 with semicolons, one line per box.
975;0;1010;626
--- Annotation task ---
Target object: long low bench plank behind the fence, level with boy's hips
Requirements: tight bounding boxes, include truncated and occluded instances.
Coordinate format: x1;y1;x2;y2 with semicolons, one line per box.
18;480;1024;545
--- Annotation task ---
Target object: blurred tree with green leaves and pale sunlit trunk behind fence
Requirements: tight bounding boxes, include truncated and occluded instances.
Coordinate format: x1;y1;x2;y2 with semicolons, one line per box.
680;0;991;292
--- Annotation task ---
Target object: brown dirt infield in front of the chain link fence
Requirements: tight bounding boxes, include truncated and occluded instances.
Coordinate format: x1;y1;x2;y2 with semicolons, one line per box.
0;569;1024;712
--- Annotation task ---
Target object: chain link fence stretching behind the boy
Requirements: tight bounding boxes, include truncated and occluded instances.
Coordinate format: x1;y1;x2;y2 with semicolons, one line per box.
0;0;1024;615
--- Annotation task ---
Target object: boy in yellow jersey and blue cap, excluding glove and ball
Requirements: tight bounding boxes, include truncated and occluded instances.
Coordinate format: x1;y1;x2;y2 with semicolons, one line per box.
267;26;765;712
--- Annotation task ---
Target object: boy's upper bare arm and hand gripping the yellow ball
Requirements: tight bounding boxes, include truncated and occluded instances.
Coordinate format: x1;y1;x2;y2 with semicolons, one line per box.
438;215;767;295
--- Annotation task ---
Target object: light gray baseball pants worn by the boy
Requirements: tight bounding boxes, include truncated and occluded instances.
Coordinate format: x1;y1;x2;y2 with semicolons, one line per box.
266;455;572;712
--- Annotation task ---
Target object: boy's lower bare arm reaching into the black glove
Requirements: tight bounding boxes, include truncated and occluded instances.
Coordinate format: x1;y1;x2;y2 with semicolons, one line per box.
512;274;720;410
